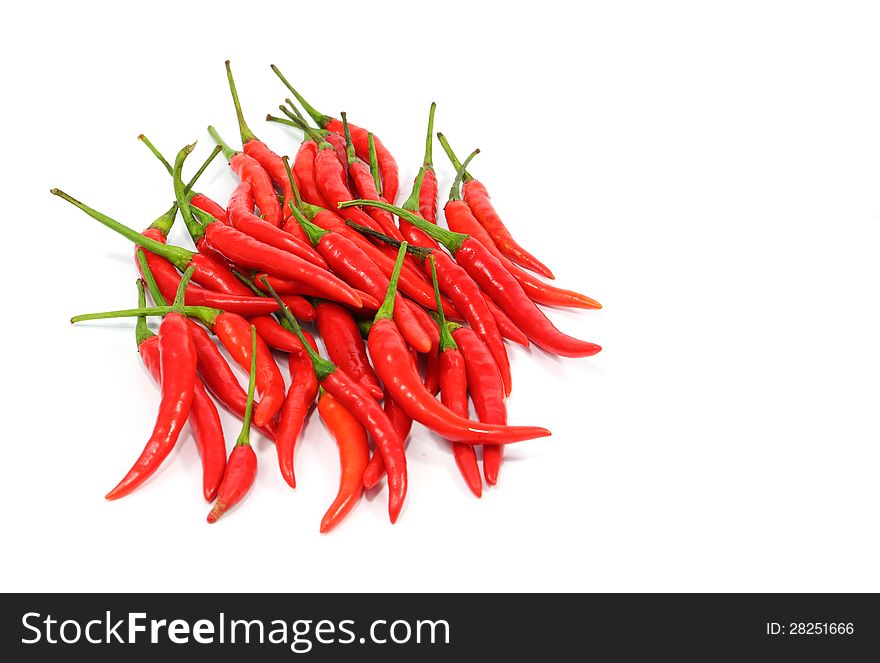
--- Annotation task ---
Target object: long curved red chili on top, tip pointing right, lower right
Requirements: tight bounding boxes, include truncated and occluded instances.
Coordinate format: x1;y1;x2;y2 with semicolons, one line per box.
367;241;550;444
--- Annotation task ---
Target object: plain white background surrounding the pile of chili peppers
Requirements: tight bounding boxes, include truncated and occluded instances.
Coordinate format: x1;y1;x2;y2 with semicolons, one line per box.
0;0;880;591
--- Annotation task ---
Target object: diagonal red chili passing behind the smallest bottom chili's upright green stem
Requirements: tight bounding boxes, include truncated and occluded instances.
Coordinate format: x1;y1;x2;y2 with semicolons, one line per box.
136;250;278;444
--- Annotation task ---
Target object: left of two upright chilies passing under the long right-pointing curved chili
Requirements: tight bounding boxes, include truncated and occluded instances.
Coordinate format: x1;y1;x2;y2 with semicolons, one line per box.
429;256;482;497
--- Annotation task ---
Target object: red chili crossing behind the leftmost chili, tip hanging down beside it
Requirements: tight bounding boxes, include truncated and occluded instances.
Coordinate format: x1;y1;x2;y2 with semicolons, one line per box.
135;279;226;502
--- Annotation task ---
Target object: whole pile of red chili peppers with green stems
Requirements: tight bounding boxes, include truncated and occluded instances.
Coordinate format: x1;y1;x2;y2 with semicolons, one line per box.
52;62;601;532
